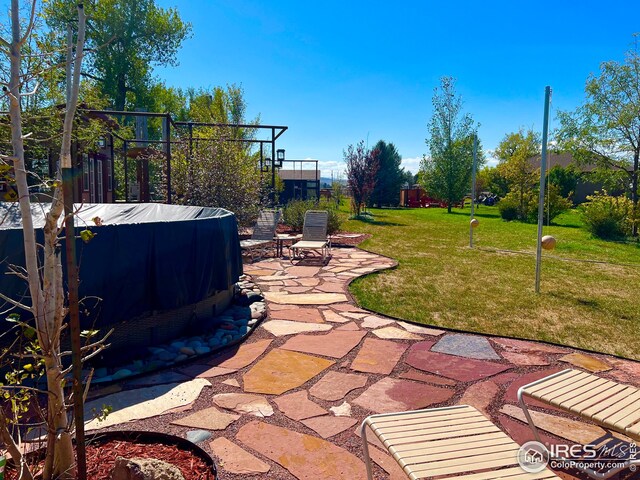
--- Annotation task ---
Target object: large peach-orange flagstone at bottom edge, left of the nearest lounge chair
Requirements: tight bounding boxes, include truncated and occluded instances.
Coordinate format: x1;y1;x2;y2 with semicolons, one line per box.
236;422;365;480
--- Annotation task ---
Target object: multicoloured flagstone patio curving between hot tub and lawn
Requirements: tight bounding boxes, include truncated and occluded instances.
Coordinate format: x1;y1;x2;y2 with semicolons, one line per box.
88;248;640;480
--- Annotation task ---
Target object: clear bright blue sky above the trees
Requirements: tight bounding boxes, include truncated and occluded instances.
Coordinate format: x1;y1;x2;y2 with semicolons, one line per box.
156;0;640;176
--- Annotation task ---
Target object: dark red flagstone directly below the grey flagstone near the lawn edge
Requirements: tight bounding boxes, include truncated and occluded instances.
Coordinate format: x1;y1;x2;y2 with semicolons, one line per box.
406;341;511;382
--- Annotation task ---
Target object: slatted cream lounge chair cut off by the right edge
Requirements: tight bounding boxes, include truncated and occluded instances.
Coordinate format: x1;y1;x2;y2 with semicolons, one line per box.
518;368;640;477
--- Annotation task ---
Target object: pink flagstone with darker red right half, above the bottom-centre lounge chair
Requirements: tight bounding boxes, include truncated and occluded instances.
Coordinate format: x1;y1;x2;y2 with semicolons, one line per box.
353;377;455;413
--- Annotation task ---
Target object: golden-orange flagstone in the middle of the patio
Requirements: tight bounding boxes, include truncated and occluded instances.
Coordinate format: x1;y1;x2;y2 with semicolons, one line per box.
242;349;334;395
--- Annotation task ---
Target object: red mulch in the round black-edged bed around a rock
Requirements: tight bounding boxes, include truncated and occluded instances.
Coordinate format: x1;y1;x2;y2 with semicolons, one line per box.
6;440;215;480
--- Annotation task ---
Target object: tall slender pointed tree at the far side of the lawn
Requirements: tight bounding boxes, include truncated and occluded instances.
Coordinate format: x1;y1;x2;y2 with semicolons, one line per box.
420;77;483;213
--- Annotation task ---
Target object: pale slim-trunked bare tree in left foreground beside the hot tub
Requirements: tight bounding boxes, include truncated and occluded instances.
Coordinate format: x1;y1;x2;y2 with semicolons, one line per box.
0;0;92;480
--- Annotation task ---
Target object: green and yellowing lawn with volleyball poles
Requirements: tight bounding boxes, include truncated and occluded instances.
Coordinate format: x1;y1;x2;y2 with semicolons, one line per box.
342;206;640;360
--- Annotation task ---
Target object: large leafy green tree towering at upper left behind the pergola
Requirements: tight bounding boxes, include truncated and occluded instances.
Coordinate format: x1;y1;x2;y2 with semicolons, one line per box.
45;0;191;110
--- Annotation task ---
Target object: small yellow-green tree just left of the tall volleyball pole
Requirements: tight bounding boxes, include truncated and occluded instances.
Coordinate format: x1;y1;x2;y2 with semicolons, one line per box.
495;129;540;220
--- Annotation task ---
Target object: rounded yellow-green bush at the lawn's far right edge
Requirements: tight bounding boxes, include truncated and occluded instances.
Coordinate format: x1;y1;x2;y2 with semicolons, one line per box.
581;191;633;239
